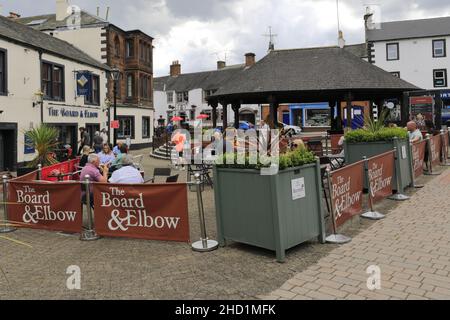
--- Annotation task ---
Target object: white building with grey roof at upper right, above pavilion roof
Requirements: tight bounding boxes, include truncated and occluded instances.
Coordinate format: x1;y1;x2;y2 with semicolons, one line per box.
365;15;450;90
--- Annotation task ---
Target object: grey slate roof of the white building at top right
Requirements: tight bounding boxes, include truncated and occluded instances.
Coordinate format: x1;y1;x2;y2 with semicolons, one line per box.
366;17;450;41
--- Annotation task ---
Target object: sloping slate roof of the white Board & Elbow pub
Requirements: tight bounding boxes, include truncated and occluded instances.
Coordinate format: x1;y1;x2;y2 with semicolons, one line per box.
0;16;109;70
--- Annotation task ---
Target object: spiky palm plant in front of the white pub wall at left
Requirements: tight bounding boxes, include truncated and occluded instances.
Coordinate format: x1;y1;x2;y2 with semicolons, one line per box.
25;124;59;168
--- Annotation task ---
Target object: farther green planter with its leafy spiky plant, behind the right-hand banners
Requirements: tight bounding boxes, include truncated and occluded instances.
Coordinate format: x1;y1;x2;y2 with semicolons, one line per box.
344;114;412;192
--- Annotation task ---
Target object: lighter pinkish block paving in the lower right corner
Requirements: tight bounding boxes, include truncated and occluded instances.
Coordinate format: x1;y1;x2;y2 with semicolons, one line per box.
261;170;450;300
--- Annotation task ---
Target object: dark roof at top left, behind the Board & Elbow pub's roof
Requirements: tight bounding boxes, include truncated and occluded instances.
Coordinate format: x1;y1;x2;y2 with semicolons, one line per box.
14;10;108;31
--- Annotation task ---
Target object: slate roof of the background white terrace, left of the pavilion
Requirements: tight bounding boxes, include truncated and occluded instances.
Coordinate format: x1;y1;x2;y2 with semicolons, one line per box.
154;64;245;92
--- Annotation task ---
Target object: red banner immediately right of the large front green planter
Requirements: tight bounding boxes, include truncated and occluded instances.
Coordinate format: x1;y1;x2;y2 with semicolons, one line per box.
331;161;364;227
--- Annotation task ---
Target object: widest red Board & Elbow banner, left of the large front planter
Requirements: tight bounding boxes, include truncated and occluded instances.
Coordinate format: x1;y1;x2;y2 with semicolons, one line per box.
94;184;190;242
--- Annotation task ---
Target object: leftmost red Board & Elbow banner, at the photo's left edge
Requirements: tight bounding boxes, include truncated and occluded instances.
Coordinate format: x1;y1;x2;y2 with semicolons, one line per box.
8;181;83;232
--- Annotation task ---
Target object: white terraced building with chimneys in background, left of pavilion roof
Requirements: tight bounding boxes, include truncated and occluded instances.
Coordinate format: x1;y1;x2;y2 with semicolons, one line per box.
154;53;261;126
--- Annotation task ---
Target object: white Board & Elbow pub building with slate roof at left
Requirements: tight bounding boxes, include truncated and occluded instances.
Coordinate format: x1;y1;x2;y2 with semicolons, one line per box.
0;16;109;171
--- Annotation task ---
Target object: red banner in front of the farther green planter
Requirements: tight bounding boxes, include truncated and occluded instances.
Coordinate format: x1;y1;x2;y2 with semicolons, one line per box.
367;151;395;202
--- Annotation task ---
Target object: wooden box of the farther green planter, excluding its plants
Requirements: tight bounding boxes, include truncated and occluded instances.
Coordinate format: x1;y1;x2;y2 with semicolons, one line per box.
344;139;413;192
